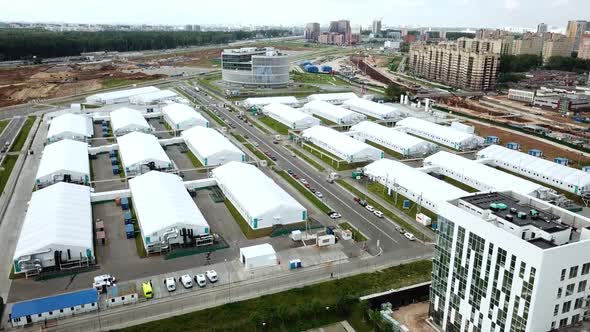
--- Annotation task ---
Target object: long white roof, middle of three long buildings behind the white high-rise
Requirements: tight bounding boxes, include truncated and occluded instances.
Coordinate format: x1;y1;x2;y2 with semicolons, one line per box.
424;151;549;195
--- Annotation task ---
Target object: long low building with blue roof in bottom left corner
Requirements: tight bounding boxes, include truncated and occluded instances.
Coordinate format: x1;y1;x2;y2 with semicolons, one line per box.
10;288;98;327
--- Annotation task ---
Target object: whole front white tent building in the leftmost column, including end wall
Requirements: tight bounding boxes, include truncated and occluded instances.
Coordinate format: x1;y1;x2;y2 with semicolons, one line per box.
13;182;94;274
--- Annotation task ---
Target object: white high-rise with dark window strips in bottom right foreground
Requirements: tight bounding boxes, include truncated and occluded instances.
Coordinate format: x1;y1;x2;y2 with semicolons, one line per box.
429;192;590;332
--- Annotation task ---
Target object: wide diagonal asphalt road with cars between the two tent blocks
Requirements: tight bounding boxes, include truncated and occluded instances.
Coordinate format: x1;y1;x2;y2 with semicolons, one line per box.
178;83;424;253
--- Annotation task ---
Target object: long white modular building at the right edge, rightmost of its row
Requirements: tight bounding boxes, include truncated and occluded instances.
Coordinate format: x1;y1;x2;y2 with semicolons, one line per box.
477;145;590;195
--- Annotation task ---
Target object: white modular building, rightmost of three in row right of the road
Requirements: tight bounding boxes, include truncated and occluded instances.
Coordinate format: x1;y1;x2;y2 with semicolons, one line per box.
396;117;483;151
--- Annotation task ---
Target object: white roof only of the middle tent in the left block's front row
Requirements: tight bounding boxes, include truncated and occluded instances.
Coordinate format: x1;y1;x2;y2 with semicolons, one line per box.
129;171;209;236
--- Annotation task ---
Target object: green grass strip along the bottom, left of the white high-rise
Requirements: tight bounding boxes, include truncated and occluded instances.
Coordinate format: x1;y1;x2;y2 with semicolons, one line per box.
122;260;432;332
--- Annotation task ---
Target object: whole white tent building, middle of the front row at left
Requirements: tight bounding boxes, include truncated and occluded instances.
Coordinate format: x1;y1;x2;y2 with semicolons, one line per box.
129;171;210;252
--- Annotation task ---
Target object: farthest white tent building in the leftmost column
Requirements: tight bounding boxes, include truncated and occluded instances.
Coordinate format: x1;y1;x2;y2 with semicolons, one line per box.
47;113;94;143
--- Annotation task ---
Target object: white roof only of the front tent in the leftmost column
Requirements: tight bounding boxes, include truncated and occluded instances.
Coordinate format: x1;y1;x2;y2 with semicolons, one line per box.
14;182;93;259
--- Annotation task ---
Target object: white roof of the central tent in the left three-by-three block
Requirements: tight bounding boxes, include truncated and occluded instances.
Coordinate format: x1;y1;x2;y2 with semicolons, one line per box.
117;131;171;167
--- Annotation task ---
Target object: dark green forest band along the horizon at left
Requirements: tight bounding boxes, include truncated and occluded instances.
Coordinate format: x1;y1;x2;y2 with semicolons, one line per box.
0;29;289;61
